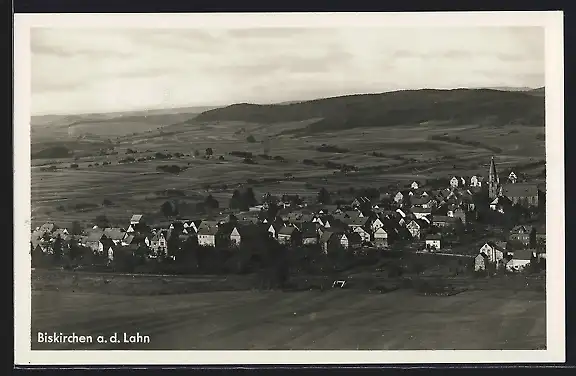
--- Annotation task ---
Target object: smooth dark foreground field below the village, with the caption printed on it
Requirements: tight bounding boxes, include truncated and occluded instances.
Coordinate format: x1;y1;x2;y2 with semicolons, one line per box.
32;270;546;350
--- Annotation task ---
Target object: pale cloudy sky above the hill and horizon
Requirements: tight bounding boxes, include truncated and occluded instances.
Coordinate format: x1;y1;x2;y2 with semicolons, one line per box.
30;26;544;115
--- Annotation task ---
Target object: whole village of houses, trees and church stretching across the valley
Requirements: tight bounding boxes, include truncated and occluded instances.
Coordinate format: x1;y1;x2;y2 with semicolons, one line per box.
31;157;546;280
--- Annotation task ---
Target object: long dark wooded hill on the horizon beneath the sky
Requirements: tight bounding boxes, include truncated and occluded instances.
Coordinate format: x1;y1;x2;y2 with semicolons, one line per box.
195;89;544;133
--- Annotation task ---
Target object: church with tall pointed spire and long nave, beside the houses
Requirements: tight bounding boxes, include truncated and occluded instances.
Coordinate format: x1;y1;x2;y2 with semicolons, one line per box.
488;157;540;207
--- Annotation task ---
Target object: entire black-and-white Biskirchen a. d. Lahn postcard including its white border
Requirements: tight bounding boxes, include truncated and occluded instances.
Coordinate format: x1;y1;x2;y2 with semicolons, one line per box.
14;12;564;364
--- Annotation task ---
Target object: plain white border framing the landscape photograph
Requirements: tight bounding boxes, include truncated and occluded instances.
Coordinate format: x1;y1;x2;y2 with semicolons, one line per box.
14;11;565;365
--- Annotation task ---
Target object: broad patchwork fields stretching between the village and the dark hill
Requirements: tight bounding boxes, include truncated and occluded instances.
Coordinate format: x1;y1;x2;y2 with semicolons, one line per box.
32;111;545;226
